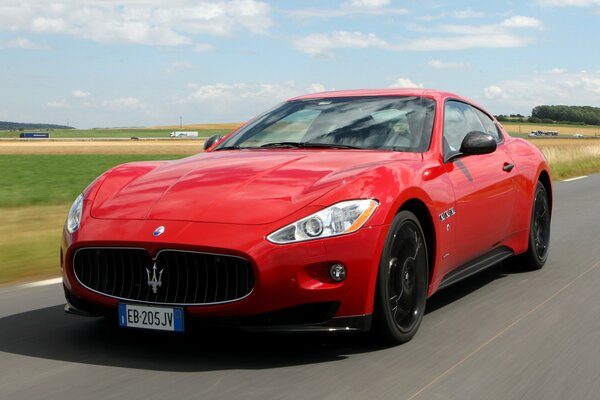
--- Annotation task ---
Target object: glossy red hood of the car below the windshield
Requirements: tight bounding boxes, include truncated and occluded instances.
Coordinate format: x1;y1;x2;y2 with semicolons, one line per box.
91;149;417;224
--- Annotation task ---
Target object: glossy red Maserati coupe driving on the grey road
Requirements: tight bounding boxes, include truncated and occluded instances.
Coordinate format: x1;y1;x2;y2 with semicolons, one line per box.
61;89;552;343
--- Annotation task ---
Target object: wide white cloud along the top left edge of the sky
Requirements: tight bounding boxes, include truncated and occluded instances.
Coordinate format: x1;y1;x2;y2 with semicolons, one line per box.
0;0;272;46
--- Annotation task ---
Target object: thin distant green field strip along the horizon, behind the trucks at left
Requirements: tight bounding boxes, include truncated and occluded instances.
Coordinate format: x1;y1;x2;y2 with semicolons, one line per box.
0;128;231;138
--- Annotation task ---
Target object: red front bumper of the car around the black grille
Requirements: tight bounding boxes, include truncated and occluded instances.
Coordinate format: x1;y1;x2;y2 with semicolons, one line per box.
61;218;387;331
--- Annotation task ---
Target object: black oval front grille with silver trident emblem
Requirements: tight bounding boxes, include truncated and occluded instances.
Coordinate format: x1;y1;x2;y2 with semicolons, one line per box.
73;248;254;304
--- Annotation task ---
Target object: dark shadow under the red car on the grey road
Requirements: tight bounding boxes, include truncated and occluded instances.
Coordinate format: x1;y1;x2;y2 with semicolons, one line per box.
0;264;520;372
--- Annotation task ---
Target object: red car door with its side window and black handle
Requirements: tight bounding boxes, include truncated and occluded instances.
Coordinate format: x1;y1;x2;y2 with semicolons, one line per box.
443;100;515;267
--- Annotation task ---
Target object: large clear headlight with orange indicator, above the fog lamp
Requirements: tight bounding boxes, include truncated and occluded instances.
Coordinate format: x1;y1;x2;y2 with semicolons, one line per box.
267;199;379;244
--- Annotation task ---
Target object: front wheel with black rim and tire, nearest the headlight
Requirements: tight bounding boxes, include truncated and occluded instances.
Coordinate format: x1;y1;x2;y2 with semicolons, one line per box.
373;211;429;345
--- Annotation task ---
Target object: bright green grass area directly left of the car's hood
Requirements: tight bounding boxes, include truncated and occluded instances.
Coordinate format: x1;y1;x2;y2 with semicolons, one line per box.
0;154;188;208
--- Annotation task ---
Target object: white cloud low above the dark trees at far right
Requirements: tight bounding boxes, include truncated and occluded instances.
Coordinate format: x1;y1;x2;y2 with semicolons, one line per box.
484;71;600;113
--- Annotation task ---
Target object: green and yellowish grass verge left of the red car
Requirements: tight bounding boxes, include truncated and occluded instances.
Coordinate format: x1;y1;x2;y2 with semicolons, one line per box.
0;154;186;285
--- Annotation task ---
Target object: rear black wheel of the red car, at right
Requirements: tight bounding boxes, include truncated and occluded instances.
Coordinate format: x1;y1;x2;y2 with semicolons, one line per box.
508;181;551;271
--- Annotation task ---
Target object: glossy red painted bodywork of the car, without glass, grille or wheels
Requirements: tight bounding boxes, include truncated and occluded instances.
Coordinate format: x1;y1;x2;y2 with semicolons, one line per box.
62;89;549;317
